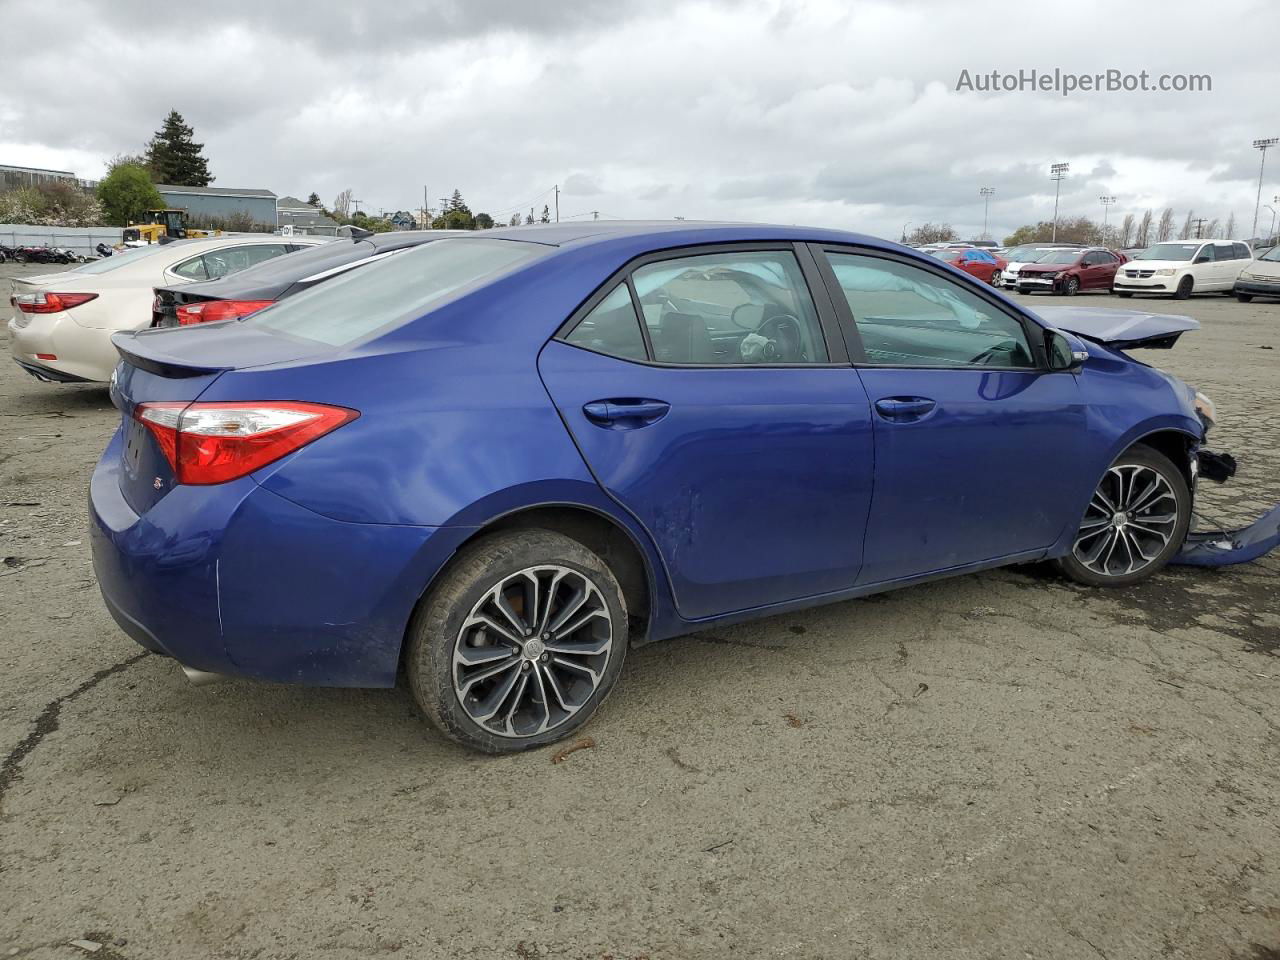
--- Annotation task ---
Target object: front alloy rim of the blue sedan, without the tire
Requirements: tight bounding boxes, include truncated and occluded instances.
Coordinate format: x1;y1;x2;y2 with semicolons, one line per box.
1073;463;1178;577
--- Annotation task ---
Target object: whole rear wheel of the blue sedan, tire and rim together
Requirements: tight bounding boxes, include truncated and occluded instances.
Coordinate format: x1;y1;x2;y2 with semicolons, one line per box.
406;530;628;754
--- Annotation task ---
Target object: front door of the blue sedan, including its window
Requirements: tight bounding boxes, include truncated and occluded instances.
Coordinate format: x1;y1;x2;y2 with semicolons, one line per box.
819;247;1088;584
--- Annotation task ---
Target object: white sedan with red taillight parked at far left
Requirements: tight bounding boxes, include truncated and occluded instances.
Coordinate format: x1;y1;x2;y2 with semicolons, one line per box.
9;234;329;383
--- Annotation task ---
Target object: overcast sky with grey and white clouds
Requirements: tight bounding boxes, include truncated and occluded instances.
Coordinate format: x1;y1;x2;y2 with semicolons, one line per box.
0;0;1280;238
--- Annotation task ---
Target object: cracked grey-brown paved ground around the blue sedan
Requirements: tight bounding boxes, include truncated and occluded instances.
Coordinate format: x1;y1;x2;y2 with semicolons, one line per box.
0;259;1280;960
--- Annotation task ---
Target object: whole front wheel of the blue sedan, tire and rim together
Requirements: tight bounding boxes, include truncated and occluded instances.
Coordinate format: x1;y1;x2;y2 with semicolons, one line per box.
1055;444;1192;586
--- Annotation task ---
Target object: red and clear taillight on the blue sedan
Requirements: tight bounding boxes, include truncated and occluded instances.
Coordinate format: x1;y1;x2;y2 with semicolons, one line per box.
133;401;360;484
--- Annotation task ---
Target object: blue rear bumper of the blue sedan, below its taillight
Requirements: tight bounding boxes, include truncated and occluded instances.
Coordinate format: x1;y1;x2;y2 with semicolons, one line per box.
90;433;470;686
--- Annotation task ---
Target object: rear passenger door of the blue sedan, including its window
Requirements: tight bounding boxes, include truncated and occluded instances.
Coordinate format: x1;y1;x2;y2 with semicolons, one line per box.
539;244;872;620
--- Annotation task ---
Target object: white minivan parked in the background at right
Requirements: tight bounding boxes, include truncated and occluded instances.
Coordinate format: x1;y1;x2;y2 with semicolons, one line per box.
1112;239;1253;300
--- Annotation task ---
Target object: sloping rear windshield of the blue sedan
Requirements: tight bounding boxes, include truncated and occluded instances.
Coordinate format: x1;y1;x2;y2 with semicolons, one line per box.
242;237;552;347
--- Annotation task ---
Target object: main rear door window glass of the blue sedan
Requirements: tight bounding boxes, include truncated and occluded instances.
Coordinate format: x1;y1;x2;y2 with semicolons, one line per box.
632;251;828;365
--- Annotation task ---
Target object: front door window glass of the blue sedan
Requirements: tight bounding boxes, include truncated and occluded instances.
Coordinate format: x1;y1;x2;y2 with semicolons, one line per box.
827;252;1036;369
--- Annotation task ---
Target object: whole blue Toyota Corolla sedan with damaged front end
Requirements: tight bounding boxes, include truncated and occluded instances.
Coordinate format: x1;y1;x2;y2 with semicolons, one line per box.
91;223;1259;753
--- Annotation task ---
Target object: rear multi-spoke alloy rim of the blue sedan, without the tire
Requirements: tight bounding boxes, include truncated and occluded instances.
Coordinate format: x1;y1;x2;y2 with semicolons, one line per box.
452;564;613;739
